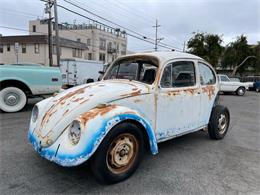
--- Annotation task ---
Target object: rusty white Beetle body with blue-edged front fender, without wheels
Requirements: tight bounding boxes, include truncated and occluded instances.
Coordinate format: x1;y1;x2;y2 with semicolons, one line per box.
28;52;229;184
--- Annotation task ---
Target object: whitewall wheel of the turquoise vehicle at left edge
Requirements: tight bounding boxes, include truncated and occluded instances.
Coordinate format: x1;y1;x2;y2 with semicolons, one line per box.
0;87;27;112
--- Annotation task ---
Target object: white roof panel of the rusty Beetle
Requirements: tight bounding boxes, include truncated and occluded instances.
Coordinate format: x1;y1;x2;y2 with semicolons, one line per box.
122;51;204;64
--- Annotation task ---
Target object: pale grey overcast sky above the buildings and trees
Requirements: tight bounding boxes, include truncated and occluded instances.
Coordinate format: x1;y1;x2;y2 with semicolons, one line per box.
0;0;260;51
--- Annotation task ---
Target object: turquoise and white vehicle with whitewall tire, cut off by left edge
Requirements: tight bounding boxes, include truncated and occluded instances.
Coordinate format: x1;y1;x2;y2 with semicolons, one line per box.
0;64;61;112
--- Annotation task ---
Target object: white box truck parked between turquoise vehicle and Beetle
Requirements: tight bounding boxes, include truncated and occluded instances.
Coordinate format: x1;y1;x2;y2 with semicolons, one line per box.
60;59;103;87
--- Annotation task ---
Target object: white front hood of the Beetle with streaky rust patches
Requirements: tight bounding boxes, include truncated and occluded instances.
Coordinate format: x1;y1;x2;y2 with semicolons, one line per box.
35;80;150;147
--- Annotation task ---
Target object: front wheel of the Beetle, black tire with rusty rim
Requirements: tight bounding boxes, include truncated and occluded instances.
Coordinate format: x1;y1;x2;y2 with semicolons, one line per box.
90;122;144;184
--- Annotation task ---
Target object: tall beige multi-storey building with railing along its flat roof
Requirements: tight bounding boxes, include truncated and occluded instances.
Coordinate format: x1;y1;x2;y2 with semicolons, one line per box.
29;20;127;63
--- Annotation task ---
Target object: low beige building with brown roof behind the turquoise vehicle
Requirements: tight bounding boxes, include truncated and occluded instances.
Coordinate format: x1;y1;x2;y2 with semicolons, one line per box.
0;35;88;66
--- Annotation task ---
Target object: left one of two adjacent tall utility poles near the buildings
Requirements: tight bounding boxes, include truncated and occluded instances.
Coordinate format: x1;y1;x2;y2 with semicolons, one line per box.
45;0;53;66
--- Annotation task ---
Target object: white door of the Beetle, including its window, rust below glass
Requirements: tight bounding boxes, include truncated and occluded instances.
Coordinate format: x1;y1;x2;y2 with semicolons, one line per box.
156;60;201;141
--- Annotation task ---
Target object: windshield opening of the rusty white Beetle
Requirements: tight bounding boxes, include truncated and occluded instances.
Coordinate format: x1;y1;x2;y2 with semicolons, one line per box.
104;58;158;84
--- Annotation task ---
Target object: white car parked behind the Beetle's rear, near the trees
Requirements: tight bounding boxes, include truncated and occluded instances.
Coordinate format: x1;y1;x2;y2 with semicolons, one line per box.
218;74;249;96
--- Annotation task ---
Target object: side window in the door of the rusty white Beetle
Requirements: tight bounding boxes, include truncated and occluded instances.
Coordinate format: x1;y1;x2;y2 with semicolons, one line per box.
161;61;196;88
